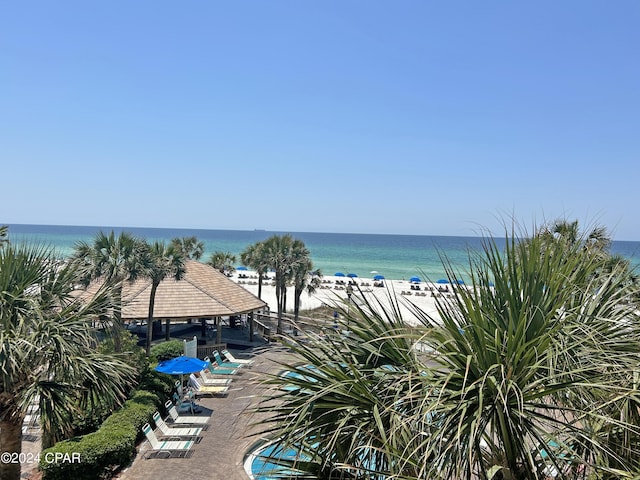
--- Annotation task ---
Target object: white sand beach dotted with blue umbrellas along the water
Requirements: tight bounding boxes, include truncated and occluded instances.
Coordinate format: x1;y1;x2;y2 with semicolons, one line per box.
231;271;451;324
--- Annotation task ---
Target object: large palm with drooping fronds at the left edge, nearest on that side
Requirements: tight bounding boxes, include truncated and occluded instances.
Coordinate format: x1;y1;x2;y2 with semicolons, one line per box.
0;245;135;479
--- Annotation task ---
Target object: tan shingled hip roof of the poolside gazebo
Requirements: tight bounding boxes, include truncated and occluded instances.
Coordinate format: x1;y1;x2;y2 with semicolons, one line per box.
105;260;266;320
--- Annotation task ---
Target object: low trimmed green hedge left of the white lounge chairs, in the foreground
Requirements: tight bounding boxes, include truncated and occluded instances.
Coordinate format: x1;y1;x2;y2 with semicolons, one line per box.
40;390;162;480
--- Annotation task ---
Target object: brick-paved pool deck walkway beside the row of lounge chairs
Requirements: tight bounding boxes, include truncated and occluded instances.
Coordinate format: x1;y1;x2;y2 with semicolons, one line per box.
117;344;291;480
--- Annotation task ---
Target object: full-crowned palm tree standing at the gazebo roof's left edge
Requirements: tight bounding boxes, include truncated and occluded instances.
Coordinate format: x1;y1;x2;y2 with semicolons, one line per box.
71;230;145;352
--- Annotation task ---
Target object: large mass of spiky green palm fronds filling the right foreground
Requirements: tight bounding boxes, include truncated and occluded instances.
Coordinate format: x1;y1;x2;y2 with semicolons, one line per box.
257;222;640;480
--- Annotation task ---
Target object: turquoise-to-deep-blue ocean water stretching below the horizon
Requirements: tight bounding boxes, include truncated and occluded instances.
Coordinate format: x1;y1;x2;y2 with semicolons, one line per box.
9;225;640;281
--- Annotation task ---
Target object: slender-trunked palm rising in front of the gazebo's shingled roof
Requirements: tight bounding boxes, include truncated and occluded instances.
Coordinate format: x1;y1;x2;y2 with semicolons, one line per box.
145;242;185;355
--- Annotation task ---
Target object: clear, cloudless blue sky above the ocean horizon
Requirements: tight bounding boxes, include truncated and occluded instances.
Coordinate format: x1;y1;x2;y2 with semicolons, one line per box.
0;0;640;240
